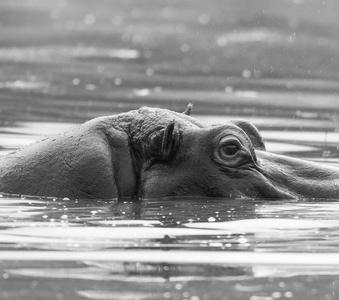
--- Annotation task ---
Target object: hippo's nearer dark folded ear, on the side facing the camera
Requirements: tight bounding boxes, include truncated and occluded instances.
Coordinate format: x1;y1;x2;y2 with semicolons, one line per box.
144;121;182;161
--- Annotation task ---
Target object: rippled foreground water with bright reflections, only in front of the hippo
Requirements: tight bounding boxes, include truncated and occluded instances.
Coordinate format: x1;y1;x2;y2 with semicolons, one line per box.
0;194;339;299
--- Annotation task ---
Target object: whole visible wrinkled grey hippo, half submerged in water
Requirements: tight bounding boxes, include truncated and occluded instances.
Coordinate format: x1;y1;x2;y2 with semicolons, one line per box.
0;107;339;199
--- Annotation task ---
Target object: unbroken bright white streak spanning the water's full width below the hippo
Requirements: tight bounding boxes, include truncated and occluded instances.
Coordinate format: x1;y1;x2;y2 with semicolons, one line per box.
0;250;339;268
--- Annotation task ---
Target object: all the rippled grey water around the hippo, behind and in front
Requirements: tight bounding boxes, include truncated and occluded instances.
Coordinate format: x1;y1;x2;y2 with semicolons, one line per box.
0;0;339;300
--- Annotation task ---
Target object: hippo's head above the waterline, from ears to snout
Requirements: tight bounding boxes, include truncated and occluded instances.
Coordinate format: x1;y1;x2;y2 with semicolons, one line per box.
121;108;339;199
